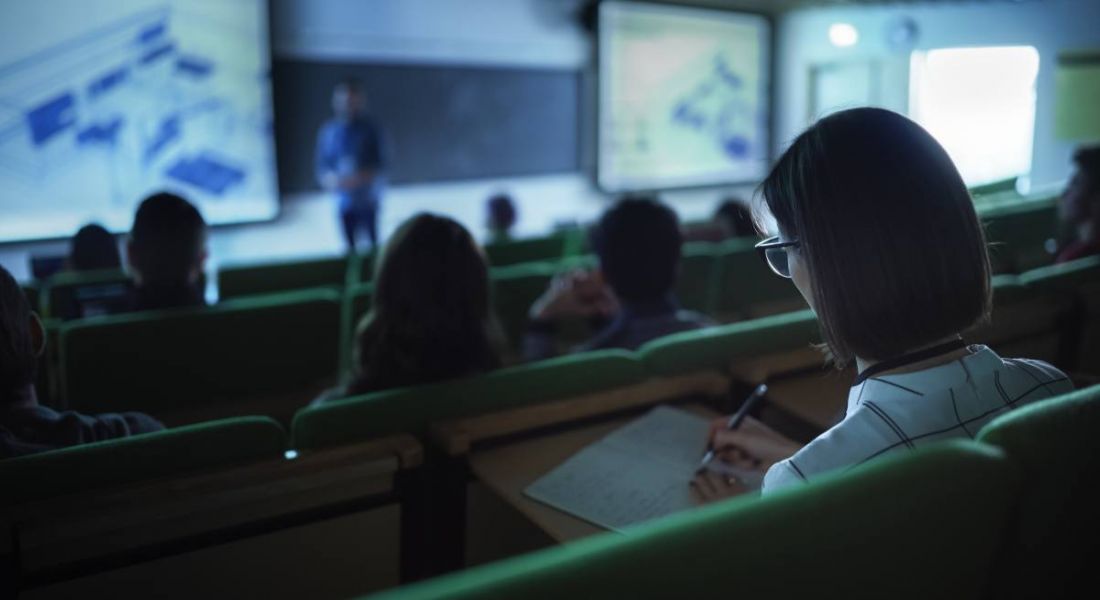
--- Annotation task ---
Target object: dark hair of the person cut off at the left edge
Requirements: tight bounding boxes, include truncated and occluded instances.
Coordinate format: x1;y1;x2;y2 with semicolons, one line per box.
0;266;39;398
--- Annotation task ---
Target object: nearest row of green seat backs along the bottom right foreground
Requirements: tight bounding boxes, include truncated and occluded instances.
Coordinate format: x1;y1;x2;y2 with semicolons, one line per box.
373;386;1100;600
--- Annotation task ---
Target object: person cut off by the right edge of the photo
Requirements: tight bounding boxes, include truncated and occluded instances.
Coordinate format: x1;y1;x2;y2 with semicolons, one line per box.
1055;146;1100;263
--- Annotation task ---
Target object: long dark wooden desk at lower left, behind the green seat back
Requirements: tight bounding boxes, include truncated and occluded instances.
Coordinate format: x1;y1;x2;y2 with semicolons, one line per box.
0;435;422;597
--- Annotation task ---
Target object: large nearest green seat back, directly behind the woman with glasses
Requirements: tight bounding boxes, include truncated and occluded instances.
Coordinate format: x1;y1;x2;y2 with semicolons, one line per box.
376;443;1020;600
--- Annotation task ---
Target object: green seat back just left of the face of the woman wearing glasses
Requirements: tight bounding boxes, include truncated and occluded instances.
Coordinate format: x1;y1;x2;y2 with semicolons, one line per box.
715;238;805;318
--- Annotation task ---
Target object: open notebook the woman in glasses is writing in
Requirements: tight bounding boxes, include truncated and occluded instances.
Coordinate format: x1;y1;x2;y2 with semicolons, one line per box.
524;406;761;531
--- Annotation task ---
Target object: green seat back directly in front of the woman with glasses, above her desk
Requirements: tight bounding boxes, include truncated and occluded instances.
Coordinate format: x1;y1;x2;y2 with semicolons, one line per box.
638;309;821;377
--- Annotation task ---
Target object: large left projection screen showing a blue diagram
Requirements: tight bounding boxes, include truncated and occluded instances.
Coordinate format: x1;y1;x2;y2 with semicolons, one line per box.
0;0;275;239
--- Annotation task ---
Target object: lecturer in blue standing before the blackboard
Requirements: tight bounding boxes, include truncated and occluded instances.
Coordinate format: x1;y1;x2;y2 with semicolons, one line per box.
315;79;389;252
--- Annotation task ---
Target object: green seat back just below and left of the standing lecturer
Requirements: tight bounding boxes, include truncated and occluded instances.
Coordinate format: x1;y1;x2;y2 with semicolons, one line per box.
218;257;348;299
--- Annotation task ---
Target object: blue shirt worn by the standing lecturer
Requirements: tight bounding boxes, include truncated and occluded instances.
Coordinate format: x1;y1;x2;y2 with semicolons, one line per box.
314;117;389;212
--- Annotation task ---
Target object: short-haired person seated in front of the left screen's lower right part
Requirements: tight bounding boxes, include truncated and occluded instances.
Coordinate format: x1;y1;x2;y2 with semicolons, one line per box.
127;193;207;310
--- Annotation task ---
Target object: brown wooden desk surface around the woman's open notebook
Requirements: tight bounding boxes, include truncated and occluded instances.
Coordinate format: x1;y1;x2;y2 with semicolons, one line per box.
469;404;718;542
